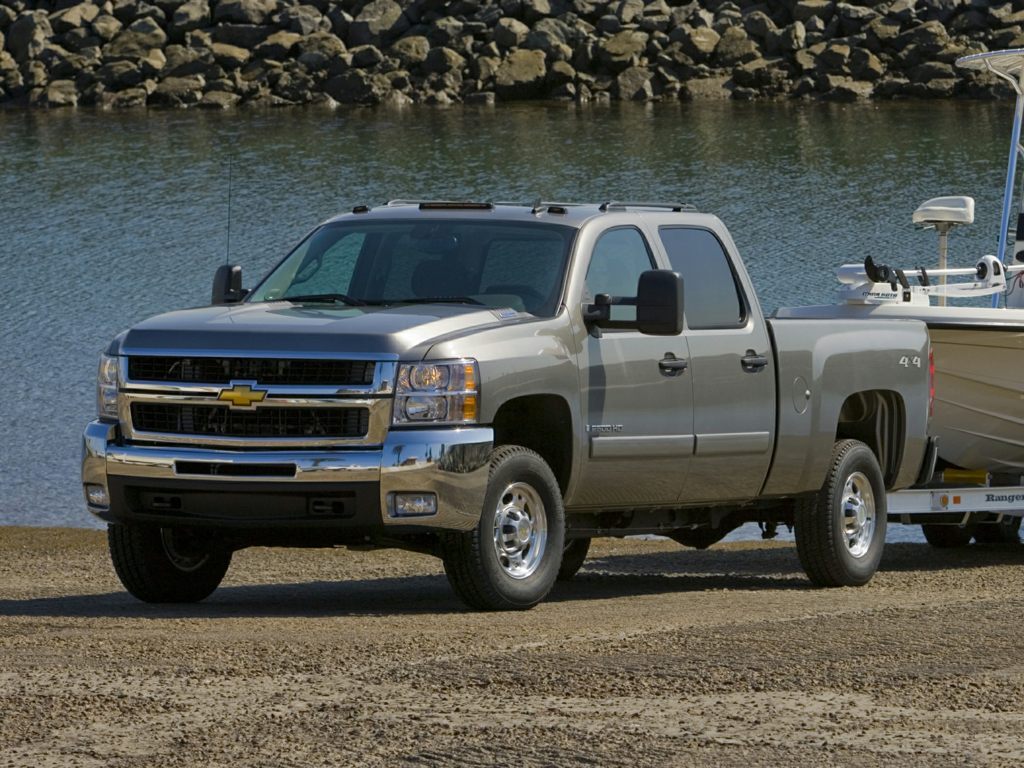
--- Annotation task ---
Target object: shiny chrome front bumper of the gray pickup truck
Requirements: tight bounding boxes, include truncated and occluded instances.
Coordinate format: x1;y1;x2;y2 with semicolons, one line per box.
82;421;494;530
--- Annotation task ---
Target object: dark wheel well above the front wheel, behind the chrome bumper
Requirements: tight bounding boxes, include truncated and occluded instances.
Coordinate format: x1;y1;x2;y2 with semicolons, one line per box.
494;394;572;494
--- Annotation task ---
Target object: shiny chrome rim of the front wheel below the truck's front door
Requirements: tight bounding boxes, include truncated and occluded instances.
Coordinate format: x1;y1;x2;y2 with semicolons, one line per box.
494;482;548;579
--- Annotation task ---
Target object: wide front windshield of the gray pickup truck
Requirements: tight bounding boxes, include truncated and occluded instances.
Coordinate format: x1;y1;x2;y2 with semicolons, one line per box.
249;219;575;316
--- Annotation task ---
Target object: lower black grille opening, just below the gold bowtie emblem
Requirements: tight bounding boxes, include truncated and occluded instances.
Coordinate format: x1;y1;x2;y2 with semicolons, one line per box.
131;402;370;438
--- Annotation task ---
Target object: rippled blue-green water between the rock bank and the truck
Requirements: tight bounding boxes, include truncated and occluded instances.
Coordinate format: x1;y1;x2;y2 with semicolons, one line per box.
0;103;1012;538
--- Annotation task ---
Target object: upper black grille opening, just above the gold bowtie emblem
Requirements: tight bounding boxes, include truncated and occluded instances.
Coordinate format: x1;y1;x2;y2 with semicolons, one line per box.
128;355;376;386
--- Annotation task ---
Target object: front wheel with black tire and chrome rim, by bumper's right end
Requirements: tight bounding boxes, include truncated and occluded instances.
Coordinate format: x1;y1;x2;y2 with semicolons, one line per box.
441;445;565;610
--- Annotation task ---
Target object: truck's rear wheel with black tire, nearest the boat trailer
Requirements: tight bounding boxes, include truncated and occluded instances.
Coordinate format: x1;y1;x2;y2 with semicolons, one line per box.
795;440;886;587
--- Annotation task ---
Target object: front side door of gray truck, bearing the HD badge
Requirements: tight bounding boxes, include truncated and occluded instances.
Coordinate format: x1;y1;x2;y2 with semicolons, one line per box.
570;226;693;508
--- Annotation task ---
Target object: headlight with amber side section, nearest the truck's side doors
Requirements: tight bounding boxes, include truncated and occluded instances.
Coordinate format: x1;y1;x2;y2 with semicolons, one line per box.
392;360;480;424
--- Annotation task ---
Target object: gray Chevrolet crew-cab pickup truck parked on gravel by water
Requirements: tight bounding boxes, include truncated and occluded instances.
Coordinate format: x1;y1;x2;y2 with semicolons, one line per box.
82;201;932;609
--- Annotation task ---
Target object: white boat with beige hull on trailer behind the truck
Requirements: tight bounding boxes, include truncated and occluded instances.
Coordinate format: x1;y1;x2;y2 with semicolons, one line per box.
778;49;1024;477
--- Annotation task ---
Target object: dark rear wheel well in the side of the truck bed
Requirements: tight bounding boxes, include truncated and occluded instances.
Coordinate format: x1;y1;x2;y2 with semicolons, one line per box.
836;389;906;487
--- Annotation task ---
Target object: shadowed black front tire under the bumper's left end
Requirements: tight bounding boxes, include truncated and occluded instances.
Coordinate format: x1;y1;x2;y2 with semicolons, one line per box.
106;523;231;603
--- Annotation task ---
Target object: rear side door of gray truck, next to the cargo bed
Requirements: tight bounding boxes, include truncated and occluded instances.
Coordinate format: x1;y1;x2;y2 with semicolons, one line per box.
658;226;775;503
